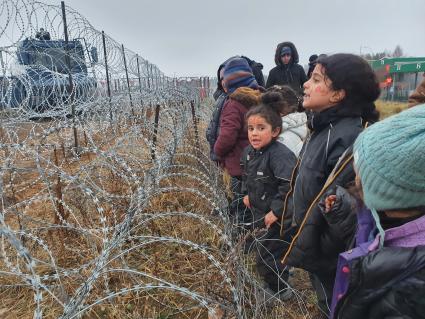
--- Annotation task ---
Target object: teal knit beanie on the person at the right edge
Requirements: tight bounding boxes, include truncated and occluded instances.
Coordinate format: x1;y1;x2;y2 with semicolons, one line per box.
354;104;425;211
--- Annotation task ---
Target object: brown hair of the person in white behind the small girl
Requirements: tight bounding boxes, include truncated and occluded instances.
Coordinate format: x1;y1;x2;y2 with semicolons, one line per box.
261;85;302;116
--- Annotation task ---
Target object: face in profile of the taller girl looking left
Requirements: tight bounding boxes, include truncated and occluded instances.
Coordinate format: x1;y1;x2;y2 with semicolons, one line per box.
303;64;345;112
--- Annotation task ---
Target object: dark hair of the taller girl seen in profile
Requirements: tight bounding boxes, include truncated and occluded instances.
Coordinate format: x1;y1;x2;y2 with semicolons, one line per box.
317;53;381;123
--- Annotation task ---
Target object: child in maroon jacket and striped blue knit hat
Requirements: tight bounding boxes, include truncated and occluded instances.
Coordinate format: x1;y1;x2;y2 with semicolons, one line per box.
214;57;261;222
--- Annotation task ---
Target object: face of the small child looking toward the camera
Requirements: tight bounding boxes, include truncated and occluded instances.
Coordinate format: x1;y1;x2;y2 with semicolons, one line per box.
248;115;280;150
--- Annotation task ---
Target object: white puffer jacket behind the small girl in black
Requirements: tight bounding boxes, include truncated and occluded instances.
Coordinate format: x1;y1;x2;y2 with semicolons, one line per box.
277;112;307;157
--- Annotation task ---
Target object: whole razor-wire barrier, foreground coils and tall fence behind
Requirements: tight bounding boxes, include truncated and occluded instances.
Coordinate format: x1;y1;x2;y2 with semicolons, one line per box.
0;0;314;318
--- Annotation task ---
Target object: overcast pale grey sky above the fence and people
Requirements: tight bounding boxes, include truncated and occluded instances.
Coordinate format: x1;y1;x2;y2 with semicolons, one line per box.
61;0;425;76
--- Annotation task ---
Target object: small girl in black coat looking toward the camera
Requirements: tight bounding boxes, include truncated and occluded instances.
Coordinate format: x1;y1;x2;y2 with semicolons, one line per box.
241;100;296;300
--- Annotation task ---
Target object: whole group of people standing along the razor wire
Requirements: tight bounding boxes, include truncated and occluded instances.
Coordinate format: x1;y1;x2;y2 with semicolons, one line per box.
206;42;425;318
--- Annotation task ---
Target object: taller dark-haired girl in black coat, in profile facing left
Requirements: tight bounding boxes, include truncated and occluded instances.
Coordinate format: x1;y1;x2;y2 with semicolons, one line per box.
282;54;380;315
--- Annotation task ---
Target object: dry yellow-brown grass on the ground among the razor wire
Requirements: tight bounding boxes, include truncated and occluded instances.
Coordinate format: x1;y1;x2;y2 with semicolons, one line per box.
0;101;407;319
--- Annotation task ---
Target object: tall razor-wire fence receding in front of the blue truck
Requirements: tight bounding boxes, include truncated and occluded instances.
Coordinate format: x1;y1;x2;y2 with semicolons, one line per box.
0;0;208;117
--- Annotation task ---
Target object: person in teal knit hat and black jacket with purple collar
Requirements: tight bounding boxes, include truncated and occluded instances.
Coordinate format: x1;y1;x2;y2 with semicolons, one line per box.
319;104;425;319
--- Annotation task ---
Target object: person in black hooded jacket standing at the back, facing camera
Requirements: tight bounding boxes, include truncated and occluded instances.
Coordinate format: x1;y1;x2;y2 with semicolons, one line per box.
266;42;307;96
